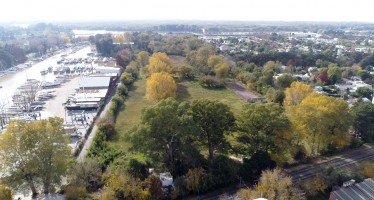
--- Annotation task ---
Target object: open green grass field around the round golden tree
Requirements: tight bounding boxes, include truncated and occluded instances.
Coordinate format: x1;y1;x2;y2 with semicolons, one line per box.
112;78;246;149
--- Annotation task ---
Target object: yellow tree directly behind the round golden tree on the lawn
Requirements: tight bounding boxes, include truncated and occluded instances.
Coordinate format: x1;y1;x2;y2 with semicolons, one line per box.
147;52;173;74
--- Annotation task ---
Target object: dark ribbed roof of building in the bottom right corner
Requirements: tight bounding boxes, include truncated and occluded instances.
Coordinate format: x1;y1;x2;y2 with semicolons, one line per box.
329;178;374;200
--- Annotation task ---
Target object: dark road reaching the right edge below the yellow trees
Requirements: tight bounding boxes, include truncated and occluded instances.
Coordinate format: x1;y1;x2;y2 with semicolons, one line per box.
284;146;374;181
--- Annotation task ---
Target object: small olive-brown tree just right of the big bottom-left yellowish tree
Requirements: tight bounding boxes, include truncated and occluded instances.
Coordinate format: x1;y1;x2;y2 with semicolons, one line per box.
68;158;102;192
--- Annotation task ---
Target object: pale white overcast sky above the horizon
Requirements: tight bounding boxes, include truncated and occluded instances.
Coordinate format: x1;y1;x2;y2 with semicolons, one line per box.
0;0;374;22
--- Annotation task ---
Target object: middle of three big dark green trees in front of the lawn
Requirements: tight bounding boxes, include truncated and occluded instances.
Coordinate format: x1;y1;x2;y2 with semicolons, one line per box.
190;100;235;171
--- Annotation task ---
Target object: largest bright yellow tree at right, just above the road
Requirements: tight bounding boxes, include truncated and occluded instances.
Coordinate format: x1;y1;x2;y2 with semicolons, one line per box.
288;93;352;155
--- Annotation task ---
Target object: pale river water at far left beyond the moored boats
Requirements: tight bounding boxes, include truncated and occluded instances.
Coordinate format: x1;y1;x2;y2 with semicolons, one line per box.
0;47;91;107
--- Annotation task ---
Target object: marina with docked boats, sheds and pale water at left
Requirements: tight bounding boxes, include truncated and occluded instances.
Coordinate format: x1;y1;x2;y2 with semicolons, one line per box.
0;46;119;152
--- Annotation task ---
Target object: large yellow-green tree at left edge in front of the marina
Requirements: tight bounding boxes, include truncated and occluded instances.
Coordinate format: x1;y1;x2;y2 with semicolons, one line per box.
0;118;70;196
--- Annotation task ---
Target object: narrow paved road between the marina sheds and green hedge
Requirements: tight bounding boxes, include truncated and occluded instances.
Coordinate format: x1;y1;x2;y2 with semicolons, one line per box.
77;81;116;162
